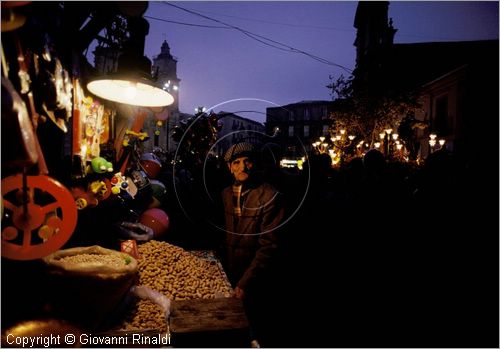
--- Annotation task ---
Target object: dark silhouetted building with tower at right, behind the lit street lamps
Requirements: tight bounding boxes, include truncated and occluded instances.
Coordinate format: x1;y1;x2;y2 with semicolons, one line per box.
354;1;499;162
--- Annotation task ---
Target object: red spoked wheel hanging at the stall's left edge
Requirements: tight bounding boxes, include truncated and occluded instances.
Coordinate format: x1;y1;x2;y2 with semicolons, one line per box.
2;174;78;260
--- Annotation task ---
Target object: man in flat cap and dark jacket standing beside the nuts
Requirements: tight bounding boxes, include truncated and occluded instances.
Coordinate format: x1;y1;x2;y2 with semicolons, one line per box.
222;142;284;341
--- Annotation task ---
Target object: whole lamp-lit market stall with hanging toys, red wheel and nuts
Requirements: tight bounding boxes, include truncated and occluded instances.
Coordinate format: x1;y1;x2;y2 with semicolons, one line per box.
1;2;248;347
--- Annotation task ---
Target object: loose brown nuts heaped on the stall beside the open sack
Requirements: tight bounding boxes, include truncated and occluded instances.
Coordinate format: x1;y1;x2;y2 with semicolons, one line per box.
116;240;232;332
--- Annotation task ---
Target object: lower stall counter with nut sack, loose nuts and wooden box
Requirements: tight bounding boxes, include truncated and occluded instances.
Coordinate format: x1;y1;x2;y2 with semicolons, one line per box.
2;240;250;347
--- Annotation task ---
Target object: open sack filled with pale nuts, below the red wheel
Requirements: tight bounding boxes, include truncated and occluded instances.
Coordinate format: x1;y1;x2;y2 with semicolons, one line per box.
43;246;138;328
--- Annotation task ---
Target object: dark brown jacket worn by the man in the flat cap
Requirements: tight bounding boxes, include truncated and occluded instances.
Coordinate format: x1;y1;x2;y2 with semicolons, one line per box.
222;183;284;290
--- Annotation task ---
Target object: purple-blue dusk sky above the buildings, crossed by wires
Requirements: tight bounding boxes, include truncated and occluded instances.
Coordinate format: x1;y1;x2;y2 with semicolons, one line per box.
141;1;499;122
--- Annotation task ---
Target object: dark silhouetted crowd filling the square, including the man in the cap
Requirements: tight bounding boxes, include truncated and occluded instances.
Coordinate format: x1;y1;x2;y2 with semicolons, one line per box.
150;140;498;347
